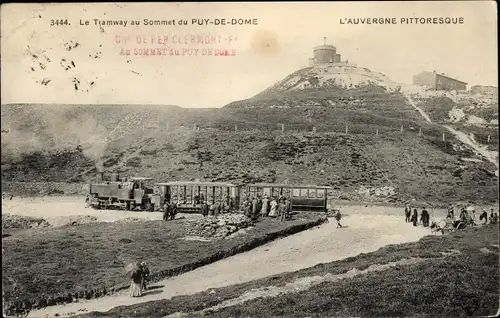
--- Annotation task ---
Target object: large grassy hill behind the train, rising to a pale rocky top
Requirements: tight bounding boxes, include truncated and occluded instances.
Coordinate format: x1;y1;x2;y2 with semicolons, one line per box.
2;65;498;201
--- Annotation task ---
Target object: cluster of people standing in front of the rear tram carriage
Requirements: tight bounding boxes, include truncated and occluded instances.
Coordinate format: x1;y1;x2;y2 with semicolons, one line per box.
241;195;292;221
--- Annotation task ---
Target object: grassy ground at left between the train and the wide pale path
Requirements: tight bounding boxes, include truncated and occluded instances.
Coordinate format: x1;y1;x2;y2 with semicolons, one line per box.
2;216;317;301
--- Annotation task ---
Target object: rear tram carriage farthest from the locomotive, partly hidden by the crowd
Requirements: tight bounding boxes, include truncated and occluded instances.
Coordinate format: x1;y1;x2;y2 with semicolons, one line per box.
242;183;331;212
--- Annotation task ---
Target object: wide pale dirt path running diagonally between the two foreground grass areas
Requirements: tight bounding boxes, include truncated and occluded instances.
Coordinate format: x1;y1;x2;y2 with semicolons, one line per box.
29;215;430;317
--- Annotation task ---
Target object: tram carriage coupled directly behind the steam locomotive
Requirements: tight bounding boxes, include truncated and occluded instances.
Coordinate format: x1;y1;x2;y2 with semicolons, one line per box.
156;181;240;213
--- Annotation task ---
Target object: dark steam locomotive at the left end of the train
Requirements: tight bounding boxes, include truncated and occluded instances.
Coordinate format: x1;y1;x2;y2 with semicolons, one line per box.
87;174;160;211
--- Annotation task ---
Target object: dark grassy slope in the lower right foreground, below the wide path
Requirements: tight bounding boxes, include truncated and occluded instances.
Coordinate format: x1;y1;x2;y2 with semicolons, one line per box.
79;225;499;317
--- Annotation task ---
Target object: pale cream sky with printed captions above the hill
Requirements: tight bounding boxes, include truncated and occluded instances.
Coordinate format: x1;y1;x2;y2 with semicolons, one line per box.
1;1;498;108
